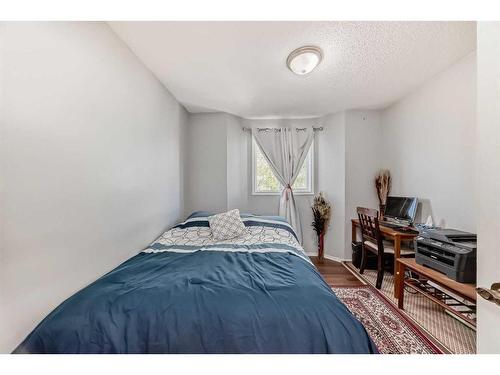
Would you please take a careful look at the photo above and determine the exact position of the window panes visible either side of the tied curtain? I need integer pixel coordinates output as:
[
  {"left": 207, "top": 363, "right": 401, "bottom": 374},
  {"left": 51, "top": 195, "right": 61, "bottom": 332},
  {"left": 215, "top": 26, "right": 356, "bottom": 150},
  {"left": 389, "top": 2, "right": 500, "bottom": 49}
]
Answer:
[{"left": 252, "top": 139, "right": 314, "bottom": 195}]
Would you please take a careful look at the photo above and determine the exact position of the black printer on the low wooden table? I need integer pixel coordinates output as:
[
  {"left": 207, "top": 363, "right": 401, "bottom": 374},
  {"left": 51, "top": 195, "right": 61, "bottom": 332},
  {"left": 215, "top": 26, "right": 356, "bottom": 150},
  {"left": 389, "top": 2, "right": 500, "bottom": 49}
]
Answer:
[{"left": 415, "top": 228, "right": 477, "bottom": 283}]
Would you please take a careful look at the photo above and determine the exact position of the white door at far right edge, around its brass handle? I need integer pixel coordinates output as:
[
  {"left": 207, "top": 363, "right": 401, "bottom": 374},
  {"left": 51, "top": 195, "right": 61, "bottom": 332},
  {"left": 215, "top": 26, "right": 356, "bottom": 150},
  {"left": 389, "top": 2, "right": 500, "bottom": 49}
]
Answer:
[{"left": 477, "top": 22, "right": 500, "bottom": 354}]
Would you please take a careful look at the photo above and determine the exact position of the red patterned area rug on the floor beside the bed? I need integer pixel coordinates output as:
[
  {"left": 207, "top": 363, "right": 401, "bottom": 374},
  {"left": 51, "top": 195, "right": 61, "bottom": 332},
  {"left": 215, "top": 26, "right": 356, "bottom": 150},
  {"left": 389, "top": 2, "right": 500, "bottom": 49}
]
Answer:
[{"left": 332, "top": 285, "right": 443, "bottom": 354}]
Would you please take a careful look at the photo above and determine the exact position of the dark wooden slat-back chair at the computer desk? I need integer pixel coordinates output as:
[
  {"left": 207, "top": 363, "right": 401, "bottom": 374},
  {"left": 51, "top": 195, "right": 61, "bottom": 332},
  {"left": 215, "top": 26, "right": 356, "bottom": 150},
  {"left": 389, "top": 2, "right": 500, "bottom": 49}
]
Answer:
[{"left": 357, "top": 207, "right": 414, "bottom": 289}]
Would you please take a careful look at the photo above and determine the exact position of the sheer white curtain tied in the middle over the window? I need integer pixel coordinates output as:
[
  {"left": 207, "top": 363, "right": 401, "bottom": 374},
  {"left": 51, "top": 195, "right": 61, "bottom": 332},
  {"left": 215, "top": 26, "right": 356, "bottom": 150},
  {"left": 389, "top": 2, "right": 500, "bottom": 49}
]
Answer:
[{"left": 252, "top": 127, "right": 314, "bottom": 243}]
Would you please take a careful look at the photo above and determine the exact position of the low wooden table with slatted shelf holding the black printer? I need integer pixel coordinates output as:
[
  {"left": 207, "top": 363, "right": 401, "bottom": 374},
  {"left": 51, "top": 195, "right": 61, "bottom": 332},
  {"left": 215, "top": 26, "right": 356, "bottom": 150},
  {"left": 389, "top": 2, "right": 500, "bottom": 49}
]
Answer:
[{"left": 395, "top": 258, "right": 477, "bottom": 326}]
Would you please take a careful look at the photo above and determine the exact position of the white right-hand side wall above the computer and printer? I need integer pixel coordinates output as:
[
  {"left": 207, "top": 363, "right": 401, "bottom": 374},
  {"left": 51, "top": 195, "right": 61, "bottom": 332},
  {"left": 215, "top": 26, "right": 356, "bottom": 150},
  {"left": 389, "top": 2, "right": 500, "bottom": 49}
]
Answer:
[{"left": 381, "top": 53, "right": 477, "bottom": 232}]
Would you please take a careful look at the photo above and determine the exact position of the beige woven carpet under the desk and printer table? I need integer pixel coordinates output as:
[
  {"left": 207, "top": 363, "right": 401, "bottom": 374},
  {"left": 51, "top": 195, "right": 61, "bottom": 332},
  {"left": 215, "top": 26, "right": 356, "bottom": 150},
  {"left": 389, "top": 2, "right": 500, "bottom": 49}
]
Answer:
[{"left": 345, "top": 262, "right": 476, "bottom": 354}]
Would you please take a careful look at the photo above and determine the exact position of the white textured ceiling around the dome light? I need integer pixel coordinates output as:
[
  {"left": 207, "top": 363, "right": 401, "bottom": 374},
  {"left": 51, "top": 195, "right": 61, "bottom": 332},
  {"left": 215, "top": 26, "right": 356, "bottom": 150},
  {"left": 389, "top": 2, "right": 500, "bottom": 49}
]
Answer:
[{"left": 109, "top": 22, "right": 476, "bottom": 118}]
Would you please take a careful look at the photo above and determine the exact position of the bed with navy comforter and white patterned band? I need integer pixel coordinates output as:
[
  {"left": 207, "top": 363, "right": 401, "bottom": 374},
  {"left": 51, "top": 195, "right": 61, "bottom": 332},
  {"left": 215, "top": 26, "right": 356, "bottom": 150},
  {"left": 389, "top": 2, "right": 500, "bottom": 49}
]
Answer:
[{"left": 14, "top": 212, "right": 377, "bottom": 353}]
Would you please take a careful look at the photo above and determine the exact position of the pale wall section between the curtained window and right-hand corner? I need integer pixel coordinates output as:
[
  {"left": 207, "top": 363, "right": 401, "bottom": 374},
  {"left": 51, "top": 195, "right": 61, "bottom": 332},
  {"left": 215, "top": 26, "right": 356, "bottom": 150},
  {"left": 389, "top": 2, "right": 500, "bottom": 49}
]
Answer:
[{"left": 317, "top": 110, "right": 381, "bottom": 260}]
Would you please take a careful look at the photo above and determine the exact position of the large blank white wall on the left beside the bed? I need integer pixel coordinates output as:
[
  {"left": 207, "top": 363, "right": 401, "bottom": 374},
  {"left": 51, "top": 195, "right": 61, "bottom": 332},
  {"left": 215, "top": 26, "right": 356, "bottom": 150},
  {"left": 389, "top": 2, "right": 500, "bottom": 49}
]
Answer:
[{"left": 0, "top": 22, "right": 187, "bottom": 352}]
